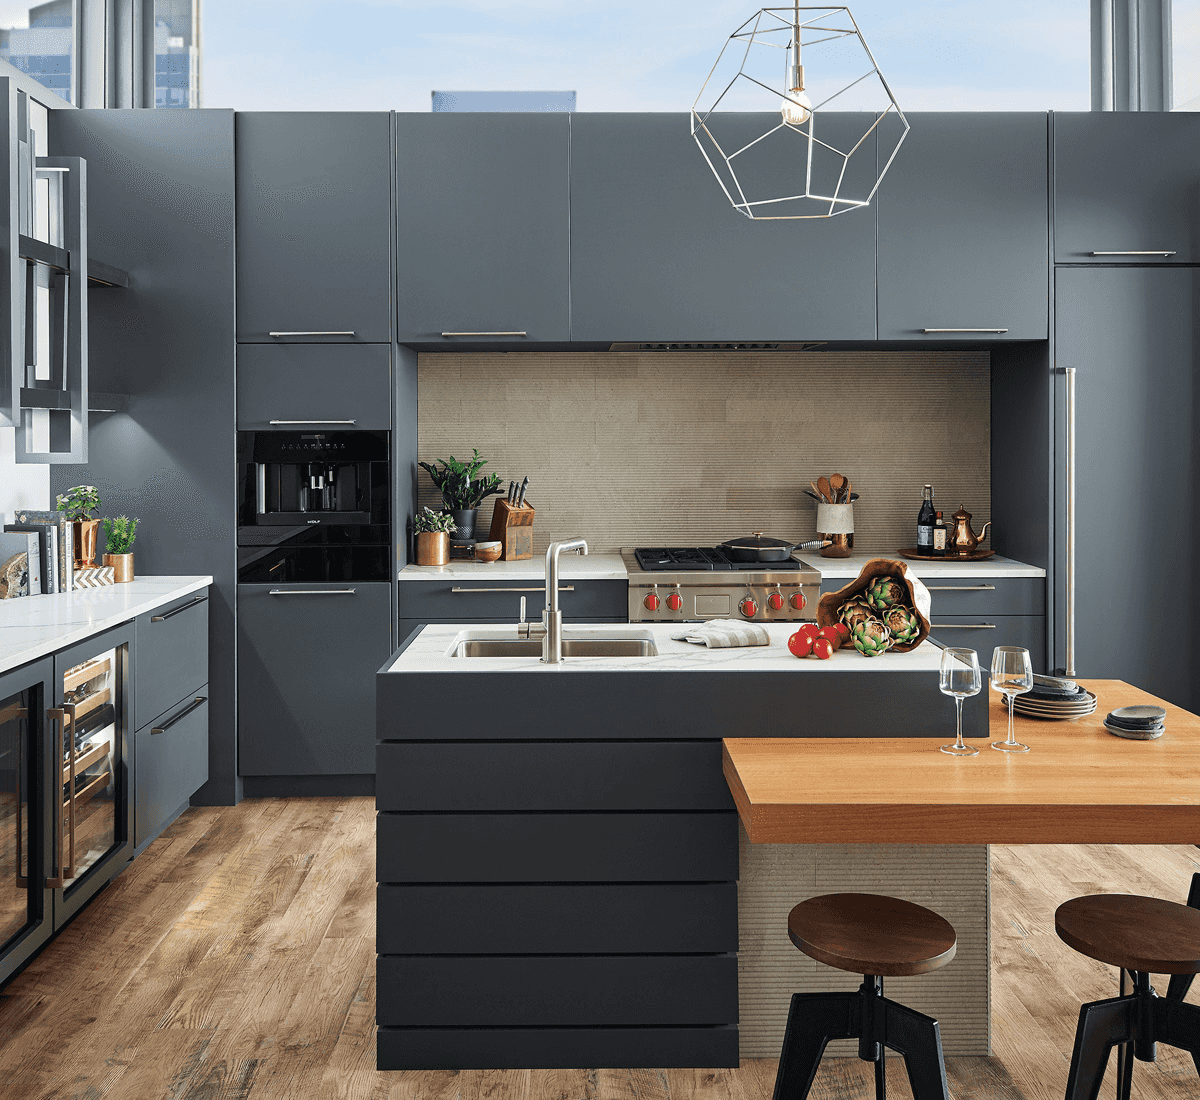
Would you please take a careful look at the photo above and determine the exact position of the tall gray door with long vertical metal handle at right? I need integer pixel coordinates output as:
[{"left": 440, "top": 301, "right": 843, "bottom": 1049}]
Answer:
[{"left": 1055, "top": 266, "right": 1200, "bottom": 710}]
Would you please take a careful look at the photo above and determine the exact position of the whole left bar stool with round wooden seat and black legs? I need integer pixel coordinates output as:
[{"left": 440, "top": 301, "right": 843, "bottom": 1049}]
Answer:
[{"left": 775, "top": 894, "right": 956, "bottom": 1100}]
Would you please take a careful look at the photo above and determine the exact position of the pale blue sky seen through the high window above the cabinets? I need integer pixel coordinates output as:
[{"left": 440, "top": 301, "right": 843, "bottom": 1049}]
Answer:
[{"left": 203, "top": 0, "right": 1099, "bottom": 110}]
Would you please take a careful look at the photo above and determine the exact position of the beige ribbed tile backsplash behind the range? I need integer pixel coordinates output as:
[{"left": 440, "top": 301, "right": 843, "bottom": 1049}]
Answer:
[{"left": 418, "top": 349, "right": 991, "bottom": 553}]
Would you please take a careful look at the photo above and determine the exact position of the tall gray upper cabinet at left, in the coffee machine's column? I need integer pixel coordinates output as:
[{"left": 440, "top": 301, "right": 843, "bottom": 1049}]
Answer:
[{"left": 234, "top": 112, "right": 391, "bottom": 343}]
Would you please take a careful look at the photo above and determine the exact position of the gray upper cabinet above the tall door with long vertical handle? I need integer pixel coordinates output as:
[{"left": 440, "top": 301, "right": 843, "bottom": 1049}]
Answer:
[{"left": 1054, "top": 112, "right": 1200, "bottom": 264}]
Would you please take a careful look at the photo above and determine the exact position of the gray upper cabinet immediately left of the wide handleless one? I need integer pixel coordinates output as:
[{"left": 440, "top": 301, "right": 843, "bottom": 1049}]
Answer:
[{"left": 396, "top": 114, "right": 571, "bottom": 347}]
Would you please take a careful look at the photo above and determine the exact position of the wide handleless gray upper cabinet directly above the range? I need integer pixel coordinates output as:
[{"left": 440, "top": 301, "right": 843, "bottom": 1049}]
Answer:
[{"left": 571, "top": 114, "right": 875, "bottom": 342}]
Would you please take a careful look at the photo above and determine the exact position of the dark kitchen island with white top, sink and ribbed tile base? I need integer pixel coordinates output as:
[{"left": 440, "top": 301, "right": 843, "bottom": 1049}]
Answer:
[{"left": 377, "top": 624, "right": 988, "bottom": 1069}]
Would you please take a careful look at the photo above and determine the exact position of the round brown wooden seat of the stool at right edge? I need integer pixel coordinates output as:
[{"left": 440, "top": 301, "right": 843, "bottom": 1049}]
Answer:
[{"left": 1054, "top": 894, "right": 1200, "bottom": 974}]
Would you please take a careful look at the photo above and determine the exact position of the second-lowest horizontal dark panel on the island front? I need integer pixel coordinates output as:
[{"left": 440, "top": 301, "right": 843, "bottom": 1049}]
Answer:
[{"left": 377, "top": 955, "right": 738, "bottom": 1027}]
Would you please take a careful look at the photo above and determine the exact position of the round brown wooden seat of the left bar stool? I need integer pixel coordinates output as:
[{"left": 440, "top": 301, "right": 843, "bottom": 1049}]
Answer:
[{"left": 787, "top": 894, "right": 955, "bottom": 978}]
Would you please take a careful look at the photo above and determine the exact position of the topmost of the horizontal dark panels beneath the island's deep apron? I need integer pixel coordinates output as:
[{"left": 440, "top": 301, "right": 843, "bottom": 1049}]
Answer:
[{"left": 376, "top": 740, "right": 733, "bottom": 812}]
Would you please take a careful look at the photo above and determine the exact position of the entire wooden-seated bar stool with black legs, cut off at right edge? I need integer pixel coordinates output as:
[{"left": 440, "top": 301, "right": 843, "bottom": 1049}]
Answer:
[{"left": 1054, "top": 879, "right": 1200, "bottom": 1100}]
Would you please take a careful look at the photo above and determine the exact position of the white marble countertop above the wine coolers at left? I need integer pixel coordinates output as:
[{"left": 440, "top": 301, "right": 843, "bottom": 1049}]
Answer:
[{"left": 0, "top": 577, "right": 212, "bottom": 672}]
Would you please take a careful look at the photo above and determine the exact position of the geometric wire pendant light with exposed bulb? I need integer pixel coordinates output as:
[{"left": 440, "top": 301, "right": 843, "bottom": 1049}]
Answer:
[{"left": 691, "top": 4, "right": 908, "bottom": 220}]
